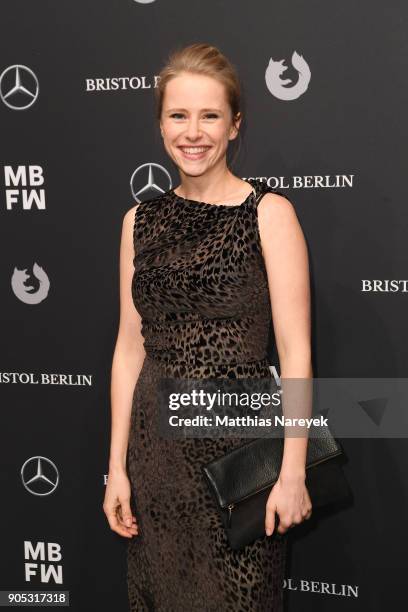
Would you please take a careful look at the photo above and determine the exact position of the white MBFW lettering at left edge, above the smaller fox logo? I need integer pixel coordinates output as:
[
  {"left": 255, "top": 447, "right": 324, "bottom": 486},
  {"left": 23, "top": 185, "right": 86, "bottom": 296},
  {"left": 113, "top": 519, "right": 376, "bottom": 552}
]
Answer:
[{"left": 4, "top": 166, "right": 45, "bottom": 210}]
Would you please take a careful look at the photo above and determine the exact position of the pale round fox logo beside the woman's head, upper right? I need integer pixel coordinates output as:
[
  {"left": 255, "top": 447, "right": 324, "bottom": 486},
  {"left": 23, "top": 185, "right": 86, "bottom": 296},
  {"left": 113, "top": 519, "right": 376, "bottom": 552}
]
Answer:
[{"left": 265, "top": 51, "right": 311, "bottom": 100}]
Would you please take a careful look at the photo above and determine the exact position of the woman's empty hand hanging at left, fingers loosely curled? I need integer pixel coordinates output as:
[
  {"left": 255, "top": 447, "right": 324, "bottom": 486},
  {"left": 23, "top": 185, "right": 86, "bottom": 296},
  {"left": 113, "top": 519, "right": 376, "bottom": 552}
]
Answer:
[{"left": 103, "top": 470, "right": 138, "bottom": 538}]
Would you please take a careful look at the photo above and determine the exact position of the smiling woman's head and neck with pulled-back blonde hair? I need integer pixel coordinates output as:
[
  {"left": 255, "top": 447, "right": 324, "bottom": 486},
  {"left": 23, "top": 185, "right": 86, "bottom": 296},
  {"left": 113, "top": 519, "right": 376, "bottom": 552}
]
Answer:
[{"left": 156, "top": 45, "right": 243, "bottom": 202}]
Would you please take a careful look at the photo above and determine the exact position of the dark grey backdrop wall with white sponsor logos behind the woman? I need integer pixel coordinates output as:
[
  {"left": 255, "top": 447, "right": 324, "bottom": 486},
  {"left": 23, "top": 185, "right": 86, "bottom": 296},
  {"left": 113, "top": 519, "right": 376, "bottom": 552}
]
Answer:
[{"left": 0, "top": 0, "right": 408, "bottom": 612}]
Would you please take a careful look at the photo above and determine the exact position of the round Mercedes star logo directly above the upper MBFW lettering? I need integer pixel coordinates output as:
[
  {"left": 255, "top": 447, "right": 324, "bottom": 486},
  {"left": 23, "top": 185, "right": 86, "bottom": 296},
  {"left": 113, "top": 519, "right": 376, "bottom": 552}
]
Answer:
[{"left": 0, "top": 64, "right": 40, "bottom": 110}]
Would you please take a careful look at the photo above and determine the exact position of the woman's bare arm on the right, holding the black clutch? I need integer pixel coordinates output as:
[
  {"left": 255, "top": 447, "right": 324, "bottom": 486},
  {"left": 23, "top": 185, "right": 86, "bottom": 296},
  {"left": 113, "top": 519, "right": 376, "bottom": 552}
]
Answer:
[{"left": 258, "top": 193, "right": 313, "bottom": 533}]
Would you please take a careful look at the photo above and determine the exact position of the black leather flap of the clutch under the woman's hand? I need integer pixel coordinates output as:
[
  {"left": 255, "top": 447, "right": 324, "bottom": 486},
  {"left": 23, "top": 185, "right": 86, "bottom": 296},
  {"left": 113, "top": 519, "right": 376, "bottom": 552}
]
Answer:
[{"left": 202, "top": 430, "right": 342, "bottom": 508}]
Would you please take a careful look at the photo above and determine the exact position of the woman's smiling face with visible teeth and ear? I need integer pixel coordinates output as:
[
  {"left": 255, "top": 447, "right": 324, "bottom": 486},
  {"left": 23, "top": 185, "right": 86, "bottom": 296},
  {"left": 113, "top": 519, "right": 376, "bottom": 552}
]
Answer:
[{"left": 160, "top": 72, "right": 241, "bottom": 176}]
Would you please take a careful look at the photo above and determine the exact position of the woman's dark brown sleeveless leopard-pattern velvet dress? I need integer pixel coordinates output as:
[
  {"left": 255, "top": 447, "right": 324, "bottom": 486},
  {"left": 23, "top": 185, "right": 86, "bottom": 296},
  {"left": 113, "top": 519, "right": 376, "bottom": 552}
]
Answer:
[{"left": 127, "top": 179, "right": 287, "bottom": 612}]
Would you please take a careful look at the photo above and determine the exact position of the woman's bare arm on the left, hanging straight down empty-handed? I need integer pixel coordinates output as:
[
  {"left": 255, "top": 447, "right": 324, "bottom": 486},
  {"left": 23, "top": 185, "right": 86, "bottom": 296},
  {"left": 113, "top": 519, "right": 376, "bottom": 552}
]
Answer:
[{"left": 103, "top": 204, "right": 146, "bottom": 538}]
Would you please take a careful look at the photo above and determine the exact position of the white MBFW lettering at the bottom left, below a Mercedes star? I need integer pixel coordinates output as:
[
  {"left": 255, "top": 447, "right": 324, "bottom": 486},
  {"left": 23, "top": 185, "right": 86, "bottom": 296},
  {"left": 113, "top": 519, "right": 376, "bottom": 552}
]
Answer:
[{"left": 24, "top": 540, "right": 63, "bottom": 584}]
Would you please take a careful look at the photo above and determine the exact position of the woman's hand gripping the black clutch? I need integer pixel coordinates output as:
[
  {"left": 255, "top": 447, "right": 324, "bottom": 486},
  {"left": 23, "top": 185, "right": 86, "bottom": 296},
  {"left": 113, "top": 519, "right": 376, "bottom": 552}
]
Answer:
[{"left": 265, "top": 473, "right": 312, "bottom": 535}]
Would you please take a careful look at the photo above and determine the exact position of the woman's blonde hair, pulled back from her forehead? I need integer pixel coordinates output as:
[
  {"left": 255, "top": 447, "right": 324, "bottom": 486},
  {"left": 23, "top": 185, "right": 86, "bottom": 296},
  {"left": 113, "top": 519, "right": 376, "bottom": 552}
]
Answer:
[{"left": 154, "top": 43, "right": 242, "bottom": 165}]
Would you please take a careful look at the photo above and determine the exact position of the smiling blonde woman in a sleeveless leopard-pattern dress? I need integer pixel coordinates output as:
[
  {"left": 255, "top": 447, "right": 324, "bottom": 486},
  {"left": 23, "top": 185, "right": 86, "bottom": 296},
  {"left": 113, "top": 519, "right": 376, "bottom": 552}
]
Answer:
[{"left": 104, "top": 44, "right": 312, "bottom": 612}]
